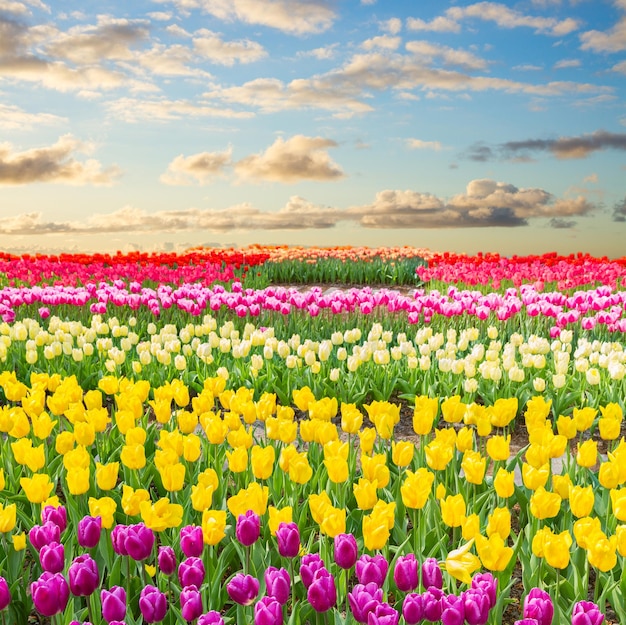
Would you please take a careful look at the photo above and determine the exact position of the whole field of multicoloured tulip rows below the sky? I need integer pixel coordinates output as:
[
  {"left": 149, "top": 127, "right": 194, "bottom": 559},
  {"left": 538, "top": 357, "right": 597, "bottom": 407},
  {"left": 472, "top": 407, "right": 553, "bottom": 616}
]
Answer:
[{"left": 0, "top": 246, "right": 626, "bottom": 625}]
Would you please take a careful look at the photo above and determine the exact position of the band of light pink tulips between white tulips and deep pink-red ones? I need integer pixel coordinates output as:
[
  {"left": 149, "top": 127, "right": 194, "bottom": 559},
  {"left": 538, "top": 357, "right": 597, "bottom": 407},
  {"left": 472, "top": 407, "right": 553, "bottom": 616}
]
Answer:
[{"left": 0, "top": 280, "right": 626, "bottom": 332}]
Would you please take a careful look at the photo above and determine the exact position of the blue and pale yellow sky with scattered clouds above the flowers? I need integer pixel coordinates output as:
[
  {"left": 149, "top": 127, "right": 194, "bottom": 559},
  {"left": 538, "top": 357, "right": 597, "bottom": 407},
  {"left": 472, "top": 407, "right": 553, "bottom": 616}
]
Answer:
[{"left": 0, "top": 0, "right": 626, "bottom": 258}]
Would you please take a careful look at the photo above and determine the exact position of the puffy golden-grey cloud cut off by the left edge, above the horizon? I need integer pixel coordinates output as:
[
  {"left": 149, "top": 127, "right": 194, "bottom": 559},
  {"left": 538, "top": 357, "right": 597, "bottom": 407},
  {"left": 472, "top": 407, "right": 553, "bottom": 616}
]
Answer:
[{"left": 0, "top": 135, "right": 121, "bottom": 185}]
